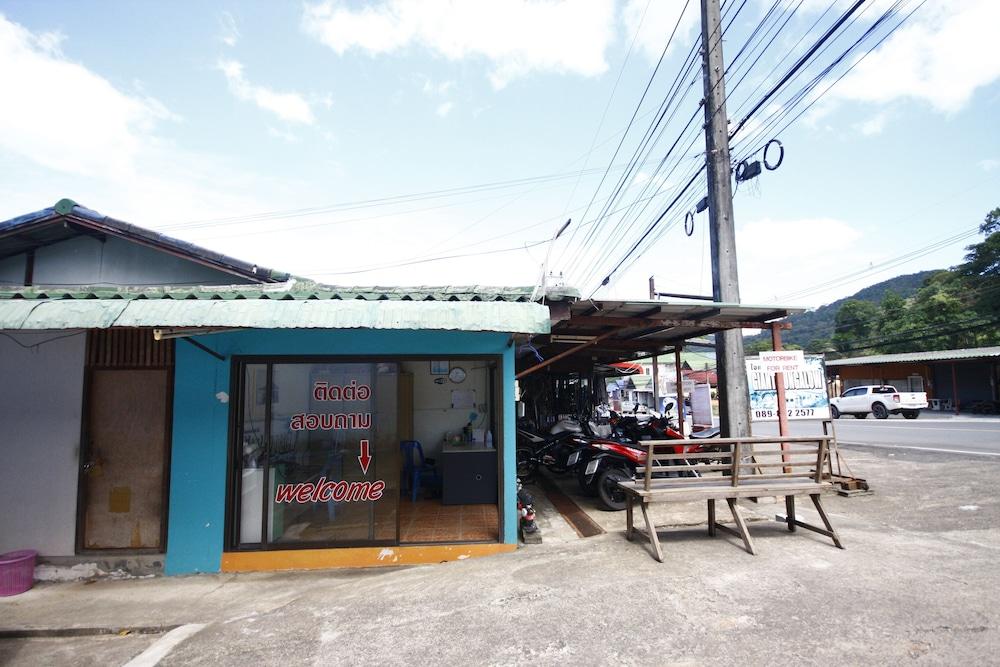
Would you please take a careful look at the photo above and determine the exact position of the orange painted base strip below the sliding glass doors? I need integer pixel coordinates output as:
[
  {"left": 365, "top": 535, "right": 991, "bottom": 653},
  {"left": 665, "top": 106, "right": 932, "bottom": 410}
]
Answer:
[{"left": 222, "top": 544, "right": 517, "bottom": 572}]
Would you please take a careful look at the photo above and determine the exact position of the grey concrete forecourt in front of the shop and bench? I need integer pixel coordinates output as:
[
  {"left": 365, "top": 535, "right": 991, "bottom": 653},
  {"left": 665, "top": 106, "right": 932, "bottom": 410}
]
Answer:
[{"left": 0, "top": 448, "right": 1000, "bottom": 665}]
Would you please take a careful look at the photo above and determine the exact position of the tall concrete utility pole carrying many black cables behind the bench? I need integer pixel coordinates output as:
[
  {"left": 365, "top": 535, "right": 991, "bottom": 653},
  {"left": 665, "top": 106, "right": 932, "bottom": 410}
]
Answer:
[{"left": 701, "top": 0, "right": 750, "bottom": 438}]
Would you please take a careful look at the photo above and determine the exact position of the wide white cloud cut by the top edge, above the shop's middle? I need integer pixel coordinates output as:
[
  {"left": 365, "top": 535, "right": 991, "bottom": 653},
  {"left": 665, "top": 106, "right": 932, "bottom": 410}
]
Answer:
[{"left": 303, "top": 0, "right": 615, "bottom": 88}]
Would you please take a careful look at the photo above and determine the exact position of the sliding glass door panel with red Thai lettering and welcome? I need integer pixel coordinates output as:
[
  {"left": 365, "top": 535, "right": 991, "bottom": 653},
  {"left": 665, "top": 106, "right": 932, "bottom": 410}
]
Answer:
[{"left": 231, "top": 358, "right": 400, "bottom": 549}]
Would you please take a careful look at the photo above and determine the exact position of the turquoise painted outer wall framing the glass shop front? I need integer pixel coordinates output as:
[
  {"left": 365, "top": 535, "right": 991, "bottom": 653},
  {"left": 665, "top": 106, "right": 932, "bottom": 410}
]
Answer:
[{"left": 165, "top": 329, "right": 517, "bottom": 574}]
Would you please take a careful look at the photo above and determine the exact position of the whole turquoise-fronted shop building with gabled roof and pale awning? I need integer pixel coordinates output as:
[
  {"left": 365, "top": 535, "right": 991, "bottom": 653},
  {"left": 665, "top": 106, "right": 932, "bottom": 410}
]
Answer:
[{"left": 0, "top": 202, "right": 549, "bottom": 574}]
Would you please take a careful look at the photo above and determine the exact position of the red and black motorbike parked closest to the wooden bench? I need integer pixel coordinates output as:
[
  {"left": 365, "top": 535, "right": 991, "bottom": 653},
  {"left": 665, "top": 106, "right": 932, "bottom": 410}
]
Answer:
[{"left": 577, "top": 408, "right": 719, "bottom": 511}]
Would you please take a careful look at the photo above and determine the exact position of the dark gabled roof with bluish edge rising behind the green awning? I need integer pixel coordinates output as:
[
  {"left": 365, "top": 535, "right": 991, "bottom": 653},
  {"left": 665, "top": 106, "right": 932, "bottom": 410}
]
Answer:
[{"left": 0, "top": 199, "right": 289, "bottom": 283}]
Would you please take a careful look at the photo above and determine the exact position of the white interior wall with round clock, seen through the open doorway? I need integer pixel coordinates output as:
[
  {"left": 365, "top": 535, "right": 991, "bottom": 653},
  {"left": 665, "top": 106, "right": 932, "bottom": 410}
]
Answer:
[{"left": 401, "top": 359, "right": 497, "bottom": 457}]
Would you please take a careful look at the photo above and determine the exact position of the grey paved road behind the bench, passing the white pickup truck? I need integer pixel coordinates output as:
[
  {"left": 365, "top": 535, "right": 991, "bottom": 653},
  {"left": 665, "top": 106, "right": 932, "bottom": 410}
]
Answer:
[{"left": 754, "top": 413, "right": 1000, "bottom": 456}]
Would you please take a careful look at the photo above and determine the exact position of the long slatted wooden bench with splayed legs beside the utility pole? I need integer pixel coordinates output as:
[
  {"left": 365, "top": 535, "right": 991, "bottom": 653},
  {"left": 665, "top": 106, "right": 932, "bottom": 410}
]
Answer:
[{"left": 618, "top": 435, "right": 844, "bottom": 563}]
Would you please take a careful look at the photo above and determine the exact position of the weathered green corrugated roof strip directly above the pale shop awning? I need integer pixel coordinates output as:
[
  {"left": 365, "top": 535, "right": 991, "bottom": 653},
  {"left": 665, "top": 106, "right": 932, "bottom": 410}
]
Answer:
[{"left": 0, "top": 280, "right": 579, "bottom": 302}]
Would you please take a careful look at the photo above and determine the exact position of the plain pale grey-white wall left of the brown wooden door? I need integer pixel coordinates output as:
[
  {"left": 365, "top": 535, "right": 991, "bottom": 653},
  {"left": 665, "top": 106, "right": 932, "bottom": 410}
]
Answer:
[{"left": 0, "top": 331, "right": 87, "bottom": 556}]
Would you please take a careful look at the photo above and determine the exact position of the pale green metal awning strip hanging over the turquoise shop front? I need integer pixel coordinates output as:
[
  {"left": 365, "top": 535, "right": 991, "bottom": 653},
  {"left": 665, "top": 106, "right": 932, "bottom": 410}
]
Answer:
[{"left": 0, "top": 299, "right": 549, "bottom": 334}]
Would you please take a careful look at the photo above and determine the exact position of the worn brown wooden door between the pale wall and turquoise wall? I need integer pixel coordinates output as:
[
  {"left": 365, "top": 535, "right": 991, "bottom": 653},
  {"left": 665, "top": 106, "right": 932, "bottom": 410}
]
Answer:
[{"left": 79, "top": 369, "right": 170, "bottom": 550}]
